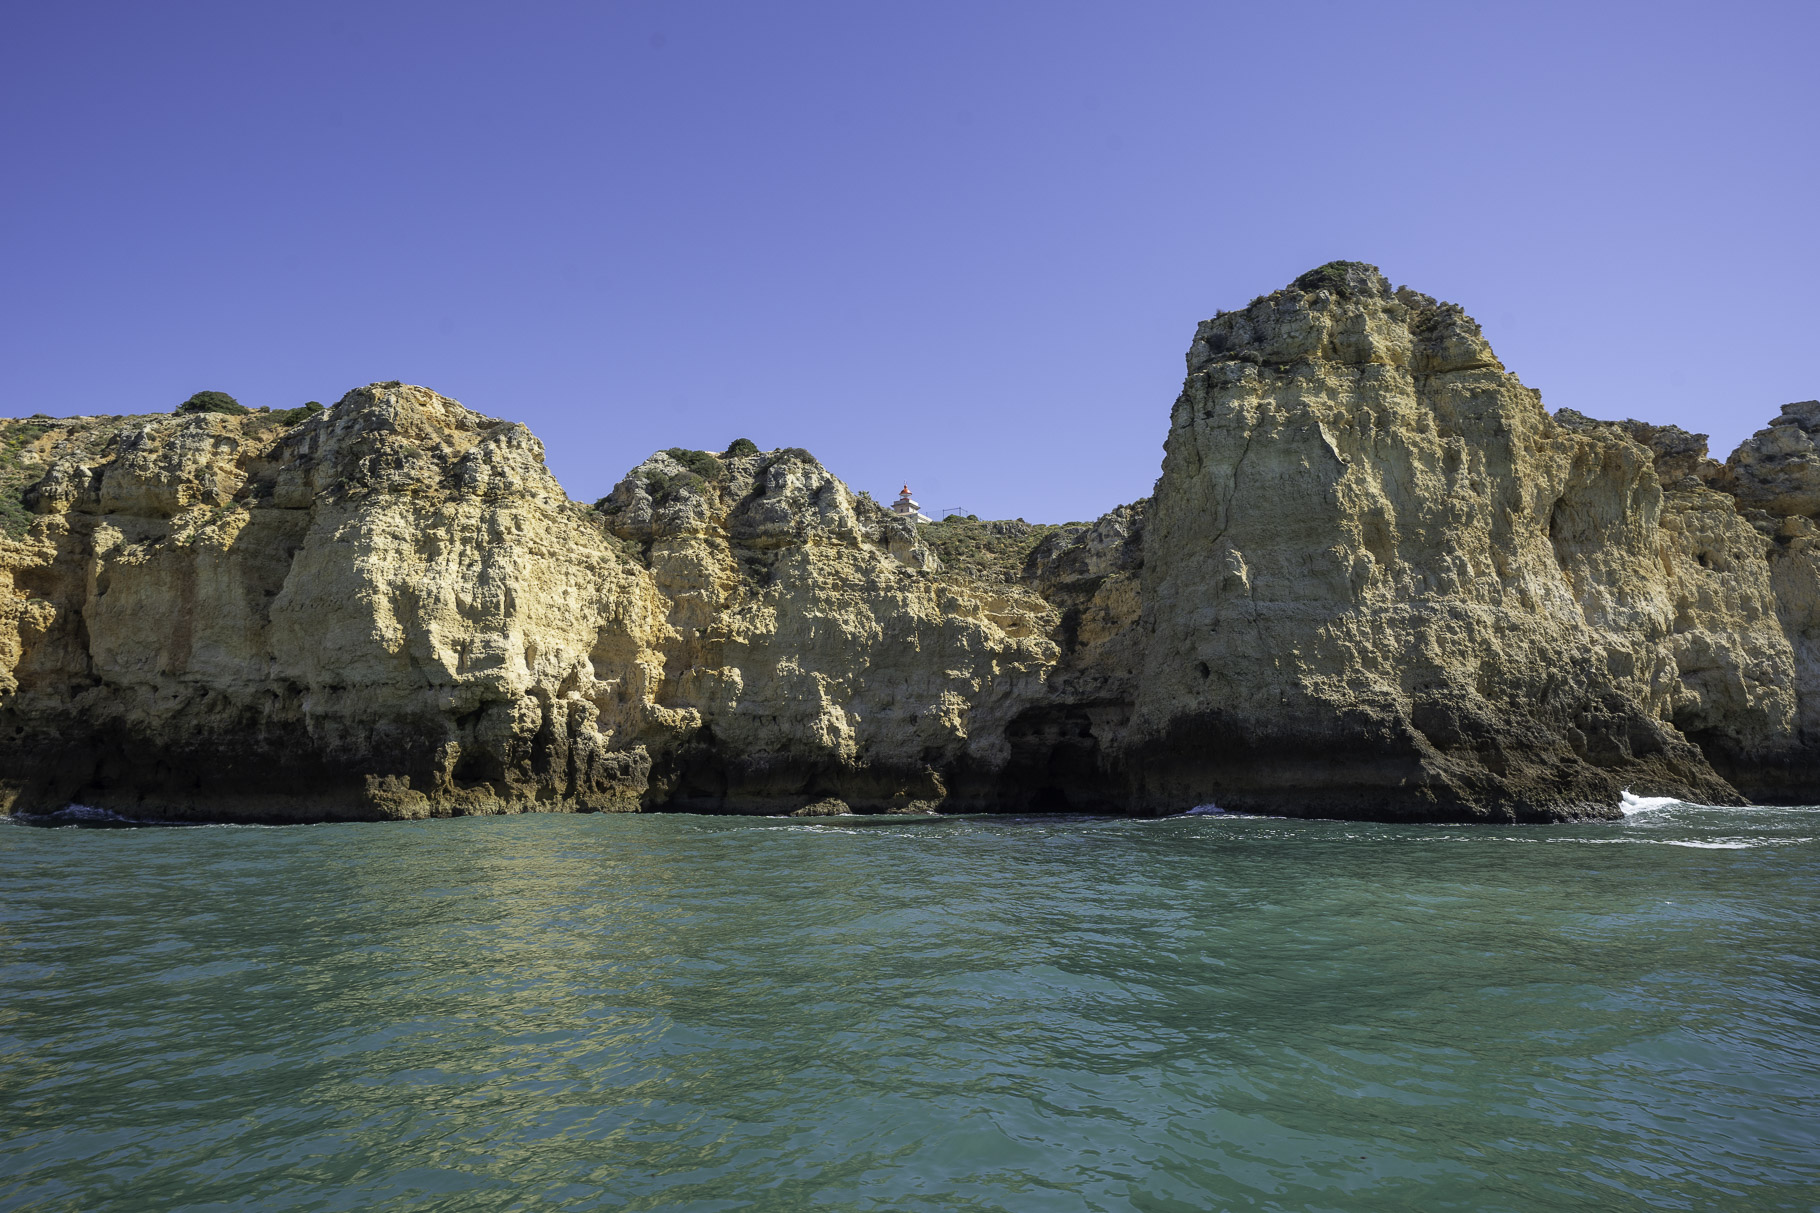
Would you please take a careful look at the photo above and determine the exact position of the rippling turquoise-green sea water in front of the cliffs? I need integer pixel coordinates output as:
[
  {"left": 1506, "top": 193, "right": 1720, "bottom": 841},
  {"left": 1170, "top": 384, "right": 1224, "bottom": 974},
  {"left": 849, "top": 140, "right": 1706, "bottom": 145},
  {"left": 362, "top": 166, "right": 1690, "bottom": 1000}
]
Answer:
[{"left": 0, "top": 805, "right": 1820, "bottom": 1213}]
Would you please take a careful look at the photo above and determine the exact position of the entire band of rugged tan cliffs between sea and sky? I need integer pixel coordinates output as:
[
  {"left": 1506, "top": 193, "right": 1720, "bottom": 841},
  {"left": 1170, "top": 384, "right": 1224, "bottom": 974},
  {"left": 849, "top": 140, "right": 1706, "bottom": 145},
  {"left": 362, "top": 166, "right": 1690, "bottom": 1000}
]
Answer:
[{"left": 0, "top": 262, "right": 1820, "bottom": 820}]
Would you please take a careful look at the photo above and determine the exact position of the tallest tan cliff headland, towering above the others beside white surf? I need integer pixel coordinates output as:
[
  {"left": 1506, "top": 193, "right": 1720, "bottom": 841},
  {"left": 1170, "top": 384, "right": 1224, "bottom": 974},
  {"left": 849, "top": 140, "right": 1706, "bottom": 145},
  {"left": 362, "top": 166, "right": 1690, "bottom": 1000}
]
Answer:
[{"left": 1117, "top": 264, "right": 1796, "bottom": 818}]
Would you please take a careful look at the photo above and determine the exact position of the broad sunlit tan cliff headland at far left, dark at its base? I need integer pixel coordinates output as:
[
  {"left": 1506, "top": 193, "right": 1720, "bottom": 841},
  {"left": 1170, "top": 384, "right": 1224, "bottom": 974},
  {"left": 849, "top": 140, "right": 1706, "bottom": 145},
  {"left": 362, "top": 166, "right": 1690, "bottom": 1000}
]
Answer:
[{"left": 0, "top": 384, "right": 662, "bottom": 820}]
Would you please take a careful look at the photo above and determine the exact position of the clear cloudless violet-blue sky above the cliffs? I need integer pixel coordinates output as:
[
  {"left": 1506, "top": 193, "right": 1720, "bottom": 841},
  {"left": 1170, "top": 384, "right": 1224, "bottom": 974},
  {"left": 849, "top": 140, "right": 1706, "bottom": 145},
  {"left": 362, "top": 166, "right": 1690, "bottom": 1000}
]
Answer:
[{"left": 0, "top": 0, "right": 1820, "bottom": 521}]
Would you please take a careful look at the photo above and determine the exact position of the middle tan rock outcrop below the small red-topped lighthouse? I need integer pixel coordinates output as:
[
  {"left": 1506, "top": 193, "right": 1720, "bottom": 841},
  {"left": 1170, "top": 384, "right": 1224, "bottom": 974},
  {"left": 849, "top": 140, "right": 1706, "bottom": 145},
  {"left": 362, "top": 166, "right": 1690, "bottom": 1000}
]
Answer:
[{"left": 601, "top": 437, "right": 1056, "bottom": 812}]
